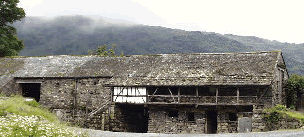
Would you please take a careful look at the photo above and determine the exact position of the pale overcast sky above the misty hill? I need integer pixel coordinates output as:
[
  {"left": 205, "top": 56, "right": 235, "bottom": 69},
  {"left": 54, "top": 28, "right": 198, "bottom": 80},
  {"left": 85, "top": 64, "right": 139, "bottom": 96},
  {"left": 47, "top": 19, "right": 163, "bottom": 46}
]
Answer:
[{"left": 20, "top": 0, "right": 304, "bottom": 43}]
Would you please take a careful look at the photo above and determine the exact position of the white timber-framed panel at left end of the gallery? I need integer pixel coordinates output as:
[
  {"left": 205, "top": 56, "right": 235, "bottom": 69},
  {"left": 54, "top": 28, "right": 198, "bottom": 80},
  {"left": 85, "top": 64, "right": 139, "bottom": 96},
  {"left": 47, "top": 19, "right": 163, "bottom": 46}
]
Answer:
[{"left": 113, "top": 87, "right": 147, "bottom": 103}]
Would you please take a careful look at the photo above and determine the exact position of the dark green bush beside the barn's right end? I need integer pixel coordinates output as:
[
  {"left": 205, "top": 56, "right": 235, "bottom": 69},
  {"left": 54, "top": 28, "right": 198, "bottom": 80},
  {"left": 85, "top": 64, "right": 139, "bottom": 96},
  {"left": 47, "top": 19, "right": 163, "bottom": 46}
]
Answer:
[{"left": 286, "top": 74, "right": 304, "bottom": 107}]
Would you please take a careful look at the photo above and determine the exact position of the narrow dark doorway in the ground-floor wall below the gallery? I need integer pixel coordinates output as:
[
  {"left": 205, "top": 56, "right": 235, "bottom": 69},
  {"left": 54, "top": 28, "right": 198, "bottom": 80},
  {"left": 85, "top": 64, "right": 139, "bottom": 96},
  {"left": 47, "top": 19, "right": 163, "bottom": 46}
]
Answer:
[{"left": 206, "top": 111, "right": 217, "bottom": 134}]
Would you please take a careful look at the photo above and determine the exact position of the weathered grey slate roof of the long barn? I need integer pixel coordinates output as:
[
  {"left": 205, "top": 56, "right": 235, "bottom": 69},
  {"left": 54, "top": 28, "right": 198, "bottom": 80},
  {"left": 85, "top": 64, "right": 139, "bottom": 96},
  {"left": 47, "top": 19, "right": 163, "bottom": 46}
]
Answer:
[{"left": 0, "top": 51, "right": 281, "bottom": 86}]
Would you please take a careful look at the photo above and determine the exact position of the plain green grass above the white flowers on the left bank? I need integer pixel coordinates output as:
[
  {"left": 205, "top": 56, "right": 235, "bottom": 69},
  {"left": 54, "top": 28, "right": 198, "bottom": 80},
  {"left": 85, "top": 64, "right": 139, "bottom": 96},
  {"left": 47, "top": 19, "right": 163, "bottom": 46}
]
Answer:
[{"left": 0, "top": 96, "right": 60, "bottom": 123}]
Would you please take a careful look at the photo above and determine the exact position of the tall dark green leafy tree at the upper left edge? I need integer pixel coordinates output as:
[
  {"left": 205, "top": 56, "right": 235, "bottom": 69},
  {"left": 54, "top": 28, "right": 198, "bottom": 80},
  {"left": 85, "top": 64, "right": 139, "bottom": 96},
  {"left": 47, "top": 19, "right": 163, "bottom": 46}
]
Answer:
[{"left": 0, "top": 0, "right": 25, "bottom": 57}]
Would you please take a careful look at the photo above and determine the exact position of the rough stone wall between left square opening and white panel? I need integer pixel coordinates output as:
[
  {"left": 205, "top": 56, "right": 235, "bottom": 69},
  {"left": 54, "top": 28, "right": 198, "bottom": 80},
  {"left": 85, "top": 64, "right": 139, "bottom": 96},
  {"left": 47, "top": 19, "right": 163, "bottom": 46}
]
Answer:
[{"left": 15, "top": 78, "right": 111, "bottom": 129}]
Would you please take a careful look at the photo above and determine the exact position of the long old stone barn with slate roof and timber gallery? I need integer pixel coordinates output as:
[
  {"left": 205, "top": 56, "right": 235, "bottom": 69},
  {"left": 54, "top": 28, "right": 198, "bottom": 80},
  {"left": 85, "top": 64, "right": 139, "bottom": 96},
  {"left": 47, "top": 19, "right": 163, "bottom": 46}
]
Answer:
[{"left": 0, "top": 51, "right": 288, "bottom": 133}]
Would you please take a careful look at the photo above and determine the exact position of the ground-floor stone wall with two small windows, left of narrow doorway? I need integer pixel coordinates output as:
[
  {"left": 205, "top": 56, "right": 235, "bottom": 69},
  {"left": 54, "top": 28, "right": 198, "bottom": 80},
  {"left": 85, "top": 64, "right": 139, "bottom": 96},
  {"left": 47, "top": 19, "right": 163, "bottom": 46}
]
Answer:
[{"left": 148, "top": 106, "right": 206, "bottom": 133}]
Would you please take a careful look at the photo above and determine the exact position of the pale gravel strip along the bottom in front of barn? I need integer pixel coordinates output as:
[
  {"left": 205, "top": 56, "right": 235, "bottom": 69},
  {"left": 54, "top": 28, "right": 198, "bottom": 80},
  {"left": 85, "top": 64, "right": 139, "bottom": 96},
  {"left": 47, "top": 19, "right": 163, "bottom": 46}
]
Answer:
[{"left": 89, "top": 130, "right": 304, "bottom": 137}]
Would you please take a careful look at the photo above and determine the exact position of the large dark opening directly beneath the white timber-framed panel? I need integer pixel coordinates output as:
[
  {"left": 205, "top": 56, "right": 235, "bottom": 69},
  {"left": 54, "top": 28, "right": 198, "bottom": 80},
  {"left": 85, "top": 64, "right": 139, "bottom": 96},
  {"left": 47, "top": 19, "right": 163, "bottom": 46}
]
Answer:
[{"left": 119, "top": 104, "right": 149, "bottom": 133}]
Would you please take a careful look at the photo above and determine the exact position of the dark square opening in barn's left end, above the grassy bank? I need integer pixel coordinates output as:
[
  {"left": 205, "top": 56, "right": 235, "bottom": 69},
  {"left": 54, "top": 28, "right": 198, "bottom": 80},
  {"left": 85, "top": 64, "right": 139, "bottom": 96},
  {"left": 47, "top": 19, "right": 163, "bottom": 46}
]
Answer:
[{"left": 21, "top": 83, "right": 41, "bottom": 102}]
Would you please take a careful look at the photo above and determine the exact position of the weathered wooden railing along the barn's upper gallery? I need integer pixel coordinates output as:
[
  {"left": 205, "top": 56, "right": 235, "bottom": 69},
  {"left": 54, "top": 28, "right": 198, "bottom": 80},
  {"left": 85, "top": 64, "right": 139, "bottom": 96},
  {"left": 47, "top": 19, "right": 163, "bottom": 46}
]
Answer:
[{"left": 112, "top": 88, "right": 272, "bottom": 105}]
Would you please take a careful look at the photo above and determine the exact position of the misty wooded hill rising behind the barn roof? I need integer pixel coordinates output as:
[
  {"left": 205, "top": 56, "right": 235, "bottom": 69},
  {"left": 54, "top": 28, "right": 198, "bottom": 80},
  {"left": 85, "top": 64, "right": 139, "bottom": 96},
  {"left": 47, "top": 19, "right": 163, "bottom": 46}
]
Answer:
[{"left": 14, "top": 16, "right": 304, "bottom": 74}]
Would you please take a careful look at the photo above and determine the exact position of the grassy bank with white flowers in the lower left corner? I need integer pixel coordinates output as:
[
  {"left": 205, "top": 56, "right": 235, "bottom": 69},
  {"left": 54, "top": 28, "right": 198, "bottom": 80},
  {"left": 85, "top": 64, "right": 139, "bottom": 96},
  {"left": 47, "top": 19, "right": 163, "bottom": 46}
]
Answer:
[{"left": 0, "top": 95, "right": 88, "bottom": 137}]
